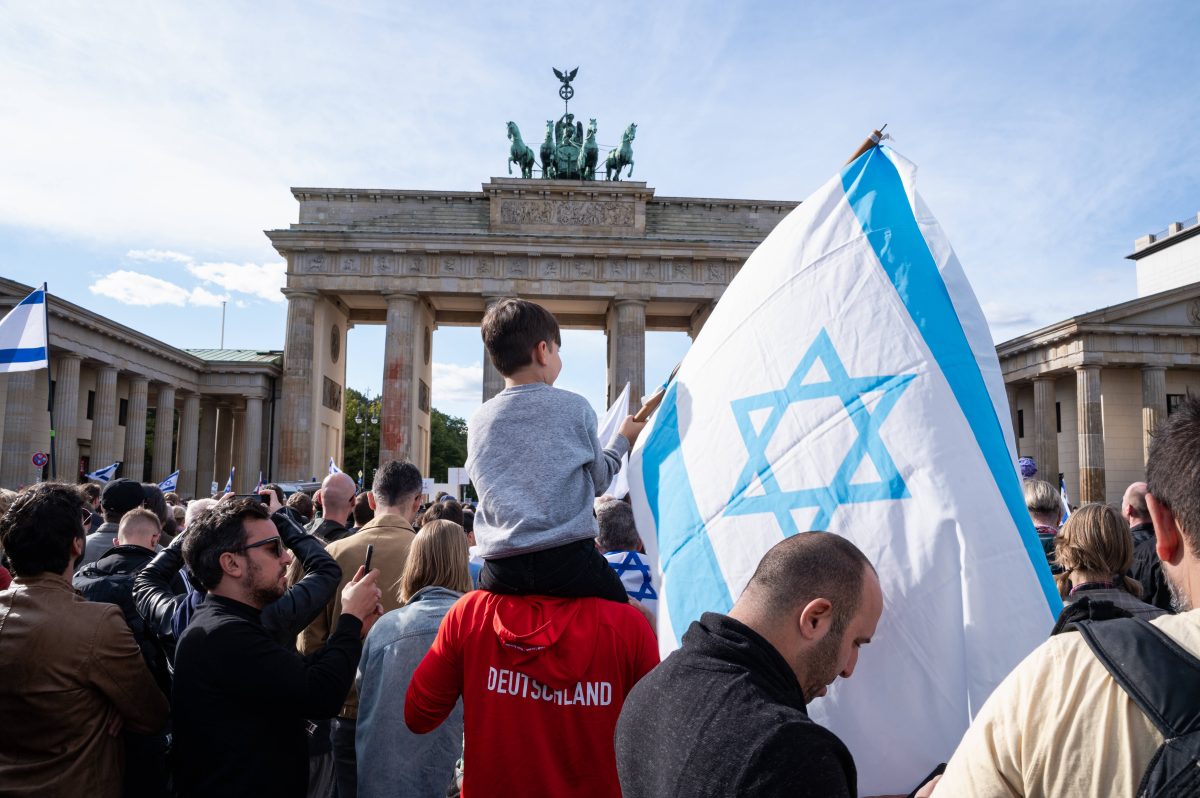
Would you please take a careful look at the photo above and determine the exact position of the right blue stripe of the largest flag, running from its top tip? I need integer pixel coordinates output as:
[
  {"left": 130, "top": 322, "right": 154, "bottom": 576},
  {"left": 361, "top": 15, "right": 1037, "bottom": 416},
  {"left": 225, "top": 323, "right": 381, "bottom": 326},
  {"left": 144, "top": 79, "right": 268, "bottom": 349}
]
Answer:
[{"left": 841, "top": 148, "right": 1062, "bottom": 614}]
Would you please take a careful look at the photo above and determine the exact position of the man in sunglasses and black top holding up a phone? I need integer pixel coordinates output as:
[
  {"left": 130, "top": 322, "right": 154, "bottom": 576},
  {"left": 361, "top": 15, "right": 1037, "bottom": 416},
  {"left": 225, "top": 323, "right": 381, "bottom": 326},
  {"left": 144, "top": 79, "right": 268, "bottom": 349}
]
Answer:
[{"left": 173, "top": 499, "right": 380, "bottom": 798}]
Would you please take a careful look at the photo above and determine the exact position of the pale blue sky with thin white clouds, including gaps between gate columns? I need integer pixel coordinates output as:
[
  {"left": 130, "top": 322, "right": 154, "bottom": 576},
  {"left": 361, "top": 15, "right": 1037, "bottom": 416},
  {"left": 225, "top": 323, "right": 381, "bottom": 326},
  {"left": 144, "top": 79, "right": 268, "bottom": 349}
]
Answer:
[{"left": 0, "top": 1, "right": 1200, "bottom": 415}]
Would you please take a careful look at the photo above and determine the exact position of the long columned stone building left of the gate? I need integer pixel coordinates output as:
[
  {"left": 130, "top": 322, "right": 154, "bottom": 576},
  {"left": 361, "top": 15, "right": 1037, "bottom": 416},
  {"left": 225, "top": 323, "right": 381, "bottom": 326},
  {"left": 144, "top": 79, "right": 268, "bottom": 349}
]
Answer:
[{"left": 0, "top": 278, "right": 283, "bottom": 498}]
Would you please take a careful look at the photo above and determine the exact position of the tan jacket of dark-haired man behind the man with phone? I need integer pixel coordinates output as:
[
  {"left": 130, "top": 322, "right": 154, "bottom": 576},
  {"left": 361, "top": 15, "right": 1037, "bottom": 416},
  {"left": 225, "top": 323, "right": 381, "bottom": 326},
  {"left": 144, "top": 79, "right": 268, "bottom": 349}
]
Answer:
[{"left": 299, "top": 515, "right": 416, "bottom": 719}]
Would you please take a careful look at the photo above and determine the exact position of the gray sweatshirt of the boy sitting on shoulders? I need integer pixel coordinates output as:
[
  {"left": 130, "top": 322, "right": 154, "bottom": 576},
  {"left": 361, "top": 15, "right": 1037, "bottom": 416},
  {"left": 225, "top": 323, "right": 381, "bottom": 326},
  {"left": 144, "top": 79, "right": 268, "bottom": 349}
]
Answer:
[{"left": 467, "top": 383, "right": 629, "bottom": 559}]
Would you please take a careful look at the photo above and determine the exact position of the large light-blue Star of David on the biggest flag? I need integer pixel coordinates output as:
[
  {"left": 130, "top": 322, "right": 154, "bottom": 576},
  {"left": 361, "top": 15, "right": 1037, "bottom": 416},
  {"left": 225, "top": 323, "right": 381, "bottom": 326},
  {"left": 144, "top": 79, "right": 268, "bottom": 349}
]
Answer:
[{"left": 725, "top": 329, "right": 913, "bottom": 535}]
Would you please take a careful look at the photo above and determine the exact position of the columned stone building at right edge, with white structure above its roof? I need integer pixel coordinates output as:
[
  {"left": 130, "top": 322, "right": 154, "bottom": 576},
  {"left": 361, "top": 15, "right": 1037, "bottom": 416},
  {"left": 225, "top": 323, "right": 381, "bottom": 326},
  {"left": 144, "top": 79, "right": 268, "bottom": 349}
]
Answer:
[{"left": 997, "top": 220, "right": 1200, "bottom": 504}]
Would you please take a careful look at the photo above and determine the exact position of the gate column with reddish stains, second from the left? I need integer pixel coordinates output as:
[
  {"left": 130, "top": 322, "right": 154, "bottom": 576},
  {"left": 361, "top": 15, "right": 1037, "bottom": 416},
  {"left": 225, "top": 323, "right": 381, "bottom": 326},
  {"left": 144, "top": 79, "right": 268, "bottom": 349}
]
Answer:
[{"left": 379, "top": 294, "right": 420, "bottom": 463}]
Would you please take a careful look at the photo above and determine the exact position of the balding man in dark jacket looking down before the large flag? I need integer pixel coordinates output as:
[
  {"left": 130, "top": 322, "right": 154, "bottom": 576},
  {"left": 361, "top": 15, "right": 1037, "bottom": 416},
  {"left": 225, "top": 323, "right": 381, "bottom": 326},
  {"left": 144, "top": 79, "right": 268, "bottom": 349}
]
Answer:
[{"left": 617, "top": 532, "right": 883, "bottom": 798}]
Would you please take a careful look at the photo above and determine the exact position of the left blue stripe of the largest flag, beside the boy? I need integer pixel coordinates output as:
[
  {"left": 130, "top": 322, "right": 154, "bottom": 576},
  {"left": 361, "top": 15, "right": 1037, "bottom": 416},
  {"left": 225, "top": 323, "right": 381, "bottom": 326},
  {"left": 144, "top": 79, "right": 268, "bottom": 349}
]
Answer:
[{"left": 642, "top": 383, "right": 733, "bottom": 643}]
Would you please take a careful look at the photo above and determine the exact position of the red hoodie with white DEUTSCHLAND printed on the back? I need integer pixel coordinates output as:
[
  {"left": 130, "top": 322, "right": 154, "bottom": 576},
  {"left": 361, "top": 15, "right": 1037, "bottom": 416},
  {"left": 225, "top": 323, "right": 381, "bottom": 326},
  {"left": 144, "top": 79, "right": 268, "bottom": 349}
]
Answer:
[{"left": 404, "top": 590, "right": 659, "bottom": 798}]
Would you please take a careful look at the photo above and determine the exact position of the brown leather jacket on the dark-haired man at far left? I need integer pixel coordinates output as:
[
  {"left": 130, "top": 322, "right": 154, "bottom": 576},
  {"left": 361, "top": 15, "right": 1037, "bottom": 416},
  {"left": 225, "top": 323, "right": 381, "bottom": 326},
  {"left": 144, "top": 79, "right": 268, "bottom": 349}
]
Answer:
[{"left": 0, "top": 574, "right": 168, "bottom": 798}]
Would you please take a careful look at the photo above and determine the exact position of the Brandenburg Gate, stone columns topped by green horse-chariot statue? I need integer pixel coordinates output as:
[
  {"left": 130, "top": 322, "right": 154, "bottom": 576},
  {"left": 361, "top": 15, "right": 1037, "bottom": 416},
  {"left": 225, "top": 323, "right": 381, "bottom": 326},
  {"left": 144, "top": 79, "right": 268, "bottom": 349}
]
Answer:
[{"left": 266, "top": 68, "right": 796, "bottom": 480}]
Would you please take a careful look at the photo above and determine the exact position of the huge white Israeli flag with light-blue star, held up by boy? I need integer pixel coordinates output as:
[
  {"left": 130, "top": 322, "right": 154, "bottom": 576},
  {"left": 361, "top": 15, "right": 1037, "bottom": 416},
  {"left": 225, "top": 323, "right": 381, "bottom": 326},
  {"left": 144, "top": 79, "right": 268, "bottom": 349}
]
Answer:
[{"left": 630, "top": 146, "right": 1061, "bottom": 794}]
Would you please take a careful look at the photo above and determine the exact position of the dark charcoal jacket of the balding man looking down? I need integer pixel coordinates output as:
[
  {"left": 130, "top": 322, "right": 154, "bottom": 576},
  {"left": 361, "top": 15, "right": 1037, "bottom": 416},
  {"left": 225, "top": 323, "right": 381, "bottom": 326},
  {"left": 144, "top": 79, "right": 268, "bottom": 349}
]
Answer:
[{"left": 617, "top": 612, "right": 858, "bottom": 798}]
